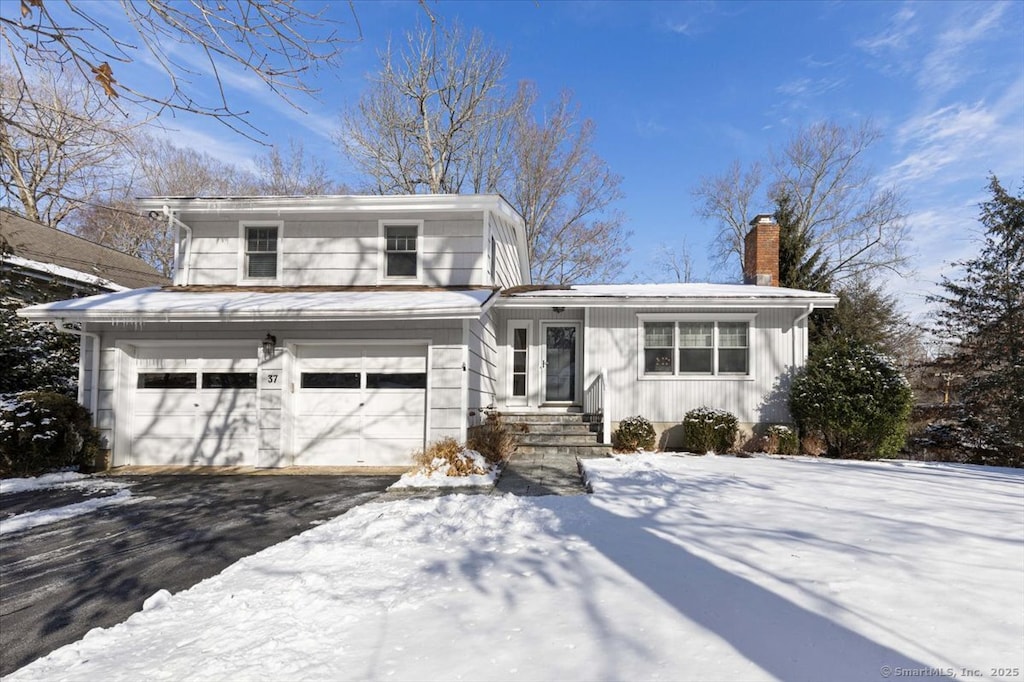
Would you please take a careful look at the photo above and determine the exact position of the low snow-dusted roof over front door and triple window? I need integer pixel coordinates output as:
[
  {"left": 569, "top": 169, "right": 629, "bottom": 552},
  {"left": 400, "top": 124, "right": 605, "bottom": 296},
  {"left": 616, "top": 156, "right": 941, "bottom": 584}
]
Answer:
[{"left": 502, "top": 284, "right": 839, "bottom": 308}]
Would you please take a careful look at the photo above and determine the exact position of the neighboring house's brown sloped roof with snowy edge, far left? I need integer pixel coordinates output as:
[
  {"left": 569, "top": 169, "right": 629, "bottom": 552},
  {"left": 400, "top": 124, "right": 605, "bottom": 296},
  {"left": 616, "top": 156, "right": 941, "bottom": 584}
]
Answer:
[{"left": 0, "top": 210, "right": 168, "bottom": 289}]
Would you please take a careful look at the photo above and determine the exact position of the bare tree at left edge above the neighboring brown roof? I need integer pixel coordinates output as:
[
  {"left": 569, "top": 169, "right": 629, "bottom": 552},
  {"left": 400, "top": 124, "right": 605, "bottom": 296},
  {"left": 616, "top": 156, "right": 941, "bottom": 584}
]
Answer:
[{"left": 0, "top": 67, "right": 130, "bottom": 227}]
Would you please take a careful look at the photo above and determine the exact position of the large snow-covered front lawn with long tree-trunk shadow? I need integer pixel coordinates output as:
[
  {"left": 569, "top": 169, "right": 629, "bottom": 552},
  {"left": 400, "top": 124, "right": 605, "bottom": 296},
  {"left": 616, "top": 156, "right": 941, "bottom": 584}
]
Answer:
[{"left": 8, "top": 455, "right": 1024, "bottom": 681}]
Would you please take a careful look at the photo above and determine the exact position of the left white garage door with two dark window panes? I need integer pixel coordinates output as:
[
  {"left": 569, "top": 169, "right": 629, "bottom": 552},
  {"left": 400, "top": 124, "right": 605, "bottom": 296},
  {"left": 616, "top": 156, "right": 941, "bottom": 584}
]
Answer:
[{"left": 131, "top": 347, "right": 258, "bottom": 466}]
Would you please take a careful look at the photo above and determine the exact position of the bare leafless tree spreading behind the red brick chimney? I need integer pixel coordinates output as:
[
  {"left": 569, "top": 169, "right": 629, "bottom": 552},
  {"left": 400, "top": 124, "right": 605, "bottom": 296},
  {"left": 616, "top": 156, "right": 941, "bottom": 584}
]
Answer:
[{"left": 693, "top": 122, "right": 907, "bottom": 284}]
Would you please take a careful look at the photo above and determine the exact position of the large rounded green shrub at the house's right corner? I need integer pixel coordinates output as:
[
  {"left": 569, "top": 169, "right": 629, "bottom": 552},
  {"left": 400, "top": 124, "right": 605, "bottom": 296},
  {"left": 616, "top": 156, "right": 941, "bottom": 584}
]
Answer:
[{"left": 790, "top": 343, "right": 912, "bottom": 459}]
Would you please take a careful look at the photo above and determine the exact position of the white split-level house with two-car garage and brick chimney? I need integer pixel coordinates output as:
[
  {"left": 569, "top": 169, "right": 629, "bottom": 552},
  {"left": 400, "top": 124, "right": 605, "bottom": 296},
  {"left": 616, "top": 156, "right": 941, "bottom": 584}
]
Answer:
[{"left": 19, "top": 195, "right": 837, "bottom": 467}]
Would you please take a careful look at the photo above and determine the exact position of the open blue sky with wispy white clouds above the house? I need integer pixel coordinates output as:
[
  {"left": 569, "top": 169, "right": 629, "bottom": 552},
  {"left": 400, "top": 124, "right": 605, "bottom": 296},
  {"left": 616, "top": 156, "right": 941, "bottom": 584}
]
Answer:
[{"left": 16, "top": 0, "right": 1024, "bottom": 319}]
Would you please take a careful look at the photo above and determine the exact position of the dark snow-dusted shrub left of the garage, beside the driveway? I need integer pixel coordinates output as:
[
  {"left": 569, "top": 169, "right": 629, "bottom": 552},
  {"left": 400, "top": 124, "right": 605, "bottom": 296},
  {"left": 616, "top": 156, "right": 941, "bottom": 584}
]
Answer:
[{"left": 0, "top": 391, "right": 99, "bottom": 477}]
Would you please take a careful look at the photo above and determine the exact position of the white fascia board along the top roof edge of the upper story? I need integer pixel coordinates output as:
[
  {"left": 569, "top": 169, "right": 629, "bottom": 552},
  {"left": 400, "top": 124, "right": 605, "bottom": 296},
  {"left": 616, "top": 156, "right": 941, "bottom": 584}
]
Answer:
[{"left": 135, "top": 195, "right": 523, "bottom": 219}]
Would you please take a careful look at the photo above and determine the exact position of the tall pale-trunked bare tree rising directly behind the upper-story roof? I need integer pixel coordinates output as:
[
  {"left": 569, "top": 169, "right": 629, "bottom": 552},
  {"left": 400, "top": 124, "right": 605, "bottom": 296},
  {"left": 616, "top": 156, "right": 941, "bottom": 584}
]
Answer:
[{"left": 337, "top": 25, "right": 523, "bottom": 195}]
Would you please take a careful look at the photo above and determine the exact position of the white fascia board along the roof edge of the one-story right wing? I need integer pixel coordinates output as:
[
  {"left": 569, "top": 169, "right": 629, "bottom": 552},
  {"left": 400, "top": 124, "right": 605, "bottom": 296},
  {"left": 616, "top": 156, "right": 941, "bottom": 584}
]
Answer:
[{"left": 498, "top": 296, "right": 839, "bottom": 308}]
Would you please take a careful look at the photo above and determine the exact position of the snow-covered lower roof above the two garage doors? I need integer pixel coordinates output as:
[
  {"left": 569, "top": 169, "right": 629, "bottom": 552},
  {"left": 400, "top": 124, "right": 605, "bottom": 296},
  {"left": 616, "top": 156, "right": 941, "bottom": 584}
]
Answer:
[{"left": 17, "top": 287, "right": 498, "bottom": 324}]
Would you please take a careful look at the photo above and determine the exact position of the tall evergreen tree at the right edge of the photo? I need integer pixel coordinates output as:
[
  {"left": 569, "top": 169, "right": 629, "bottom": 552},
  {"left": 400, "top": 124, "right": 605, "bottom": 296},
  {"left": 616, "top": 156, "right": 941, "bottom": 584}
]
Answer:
[{"left": 932, "top": 175, "right": 1024, "bottom": 448}]
